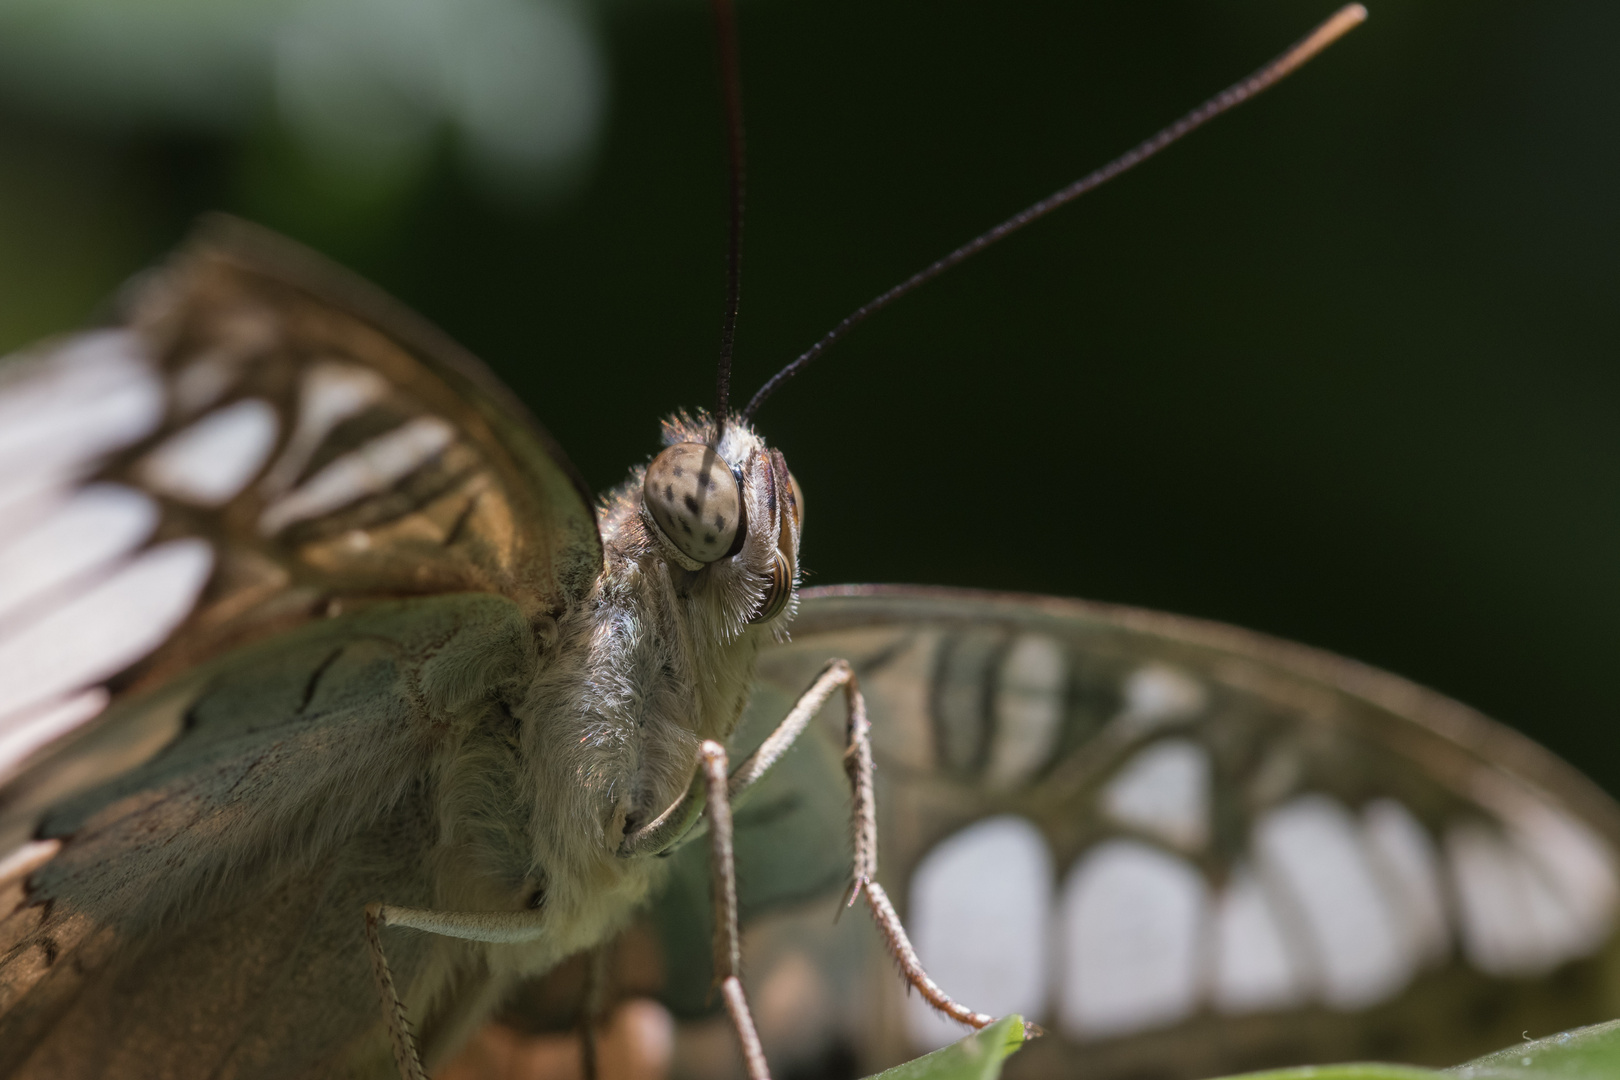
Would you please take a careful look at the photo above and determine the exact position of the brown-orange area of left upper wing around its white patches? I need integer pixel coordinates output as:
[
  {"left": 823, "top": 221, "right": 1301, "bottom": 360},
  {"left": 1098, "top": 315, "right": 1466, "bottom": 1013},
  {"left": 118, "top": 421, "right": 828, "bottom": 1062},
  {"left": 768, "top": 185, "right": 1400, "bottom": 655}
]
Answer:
[{"left": 105, "top": 217, "right": 601, "bottom": 685}]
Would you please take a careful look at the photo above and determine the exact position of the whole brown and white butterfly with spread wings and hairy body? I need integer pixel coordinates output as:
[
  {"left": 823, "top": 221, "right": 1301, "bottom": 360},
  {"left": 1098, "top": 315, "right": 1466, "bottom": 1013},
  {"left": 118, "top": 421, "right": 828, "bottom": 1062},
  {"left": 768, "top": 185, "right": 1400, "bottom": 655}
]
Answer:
[{"left": 0, "top": 6, "right": 1620, "bottom": 1077}]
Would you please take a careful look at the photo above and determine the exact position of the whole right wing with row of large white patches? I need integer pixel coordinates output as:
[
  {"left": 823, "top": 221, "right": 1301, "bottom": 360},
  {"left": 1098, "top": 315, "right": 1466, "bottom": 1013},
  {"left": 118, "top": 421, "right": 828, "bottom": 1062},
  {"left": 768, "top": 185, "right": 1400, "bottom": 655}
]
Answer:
[{"left": 644, "top": 588, "right": 1620, "bottom": 1077}]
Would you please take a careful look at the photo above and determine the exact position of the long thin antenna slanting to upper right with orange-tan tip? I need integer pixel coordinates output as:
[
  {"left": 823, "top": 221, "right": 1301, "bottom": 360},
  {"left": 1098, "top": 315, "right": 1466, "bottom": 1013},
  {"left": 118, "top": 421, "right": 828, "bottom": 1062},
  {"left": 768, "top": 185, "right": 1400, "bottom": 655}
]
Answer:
[{"left": 742, "top": 3, "right": 1367, "bottom": 423}]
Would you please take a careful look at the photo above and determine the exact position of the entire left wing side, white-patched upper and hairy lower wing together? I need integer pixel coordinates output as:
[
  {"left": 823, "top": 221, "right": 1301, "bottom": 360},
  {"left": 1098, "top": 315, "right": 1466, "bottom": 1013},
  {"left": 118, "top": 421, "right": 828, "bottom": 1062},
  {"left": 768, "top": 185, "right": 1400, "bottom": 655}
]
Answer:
[{"left": 0, "top": 220, "right": 601, "bottom": 1075}]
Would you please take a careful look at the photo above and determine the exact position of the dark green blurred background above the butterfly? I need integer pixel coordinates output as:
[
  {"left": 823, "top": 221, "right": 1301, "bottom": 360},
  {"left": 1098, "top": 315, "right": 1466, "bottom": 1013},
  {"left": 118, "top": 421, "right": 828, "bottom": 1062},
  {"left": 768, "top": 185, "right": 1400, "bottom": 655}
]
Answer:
[{"left": 0, "top": 0, "right": 1620, "bottom": 792}]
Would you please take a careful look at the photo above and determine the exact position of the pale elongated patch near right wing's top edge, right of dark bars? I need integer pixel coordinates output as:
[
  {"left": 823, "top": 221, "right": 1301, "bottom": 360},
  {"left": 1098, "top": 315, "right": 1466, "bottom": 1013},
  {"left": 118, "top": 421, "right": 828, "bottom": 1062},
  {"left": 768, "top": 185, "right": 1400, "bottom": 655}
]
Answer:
[{"left": 985, "top": 633, "right": 1069, "bottom": 790}]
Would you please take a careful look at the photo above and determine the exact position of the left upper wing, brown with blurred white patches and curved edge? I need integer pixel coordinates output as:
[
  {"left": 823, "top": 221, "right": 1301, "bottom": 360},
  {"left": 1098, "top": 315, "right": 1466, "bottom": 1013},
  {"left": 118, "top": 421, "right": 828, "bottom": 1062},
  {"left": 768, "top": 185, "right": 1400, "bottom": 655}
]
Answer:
[{"left": 0, "top": 219, "right": 601, "bottom": 858}]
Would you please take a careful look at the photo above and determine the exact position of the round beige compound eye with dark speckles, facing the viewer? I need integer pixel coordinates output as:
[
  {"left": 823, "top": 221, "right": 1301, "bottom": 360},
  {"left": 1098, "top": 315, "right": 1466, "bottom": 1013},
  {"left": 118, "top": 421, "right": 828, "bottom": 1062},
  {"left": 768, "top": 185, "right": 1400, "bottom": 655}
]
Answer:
[{"left": 642, "top": 442, "right": 744, "bottom": 562}]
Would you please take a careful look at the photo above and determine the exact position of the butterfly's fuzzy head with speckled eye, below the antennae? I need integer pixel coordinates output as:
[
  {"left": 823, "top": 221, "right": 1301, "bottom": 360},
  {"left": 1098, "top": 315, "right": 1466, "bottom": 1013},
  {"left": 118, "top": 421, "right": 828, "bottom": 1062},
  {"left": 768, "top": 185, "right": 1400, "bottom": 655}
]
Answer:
[{"left": 625, "top": 416, "right": 804, "bottom": 634}]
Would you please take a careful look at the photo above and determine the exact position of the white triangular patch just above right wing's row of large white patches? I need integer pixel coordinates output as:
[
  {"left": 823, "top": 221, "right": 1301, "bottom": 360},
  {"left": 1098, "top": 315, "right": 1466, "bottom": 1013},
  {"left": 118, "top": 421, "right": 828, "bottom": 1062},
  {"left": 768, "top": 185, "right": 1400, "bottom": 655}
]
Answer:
[{"left": 1102, "top": 738, "right": 1212, "bottom": 852}]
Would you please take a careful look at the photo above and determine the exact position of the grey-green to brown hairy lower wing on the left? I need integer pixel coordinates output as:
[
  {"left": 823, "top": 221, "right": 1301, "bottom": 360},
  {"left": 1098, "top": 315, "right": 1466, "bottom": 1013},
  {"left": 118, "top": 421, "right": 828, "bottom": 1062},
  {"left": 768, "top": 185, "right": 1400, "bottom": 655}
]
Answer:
[{"left": 0, "top": 594, "right": 536, "bottom": 1077}]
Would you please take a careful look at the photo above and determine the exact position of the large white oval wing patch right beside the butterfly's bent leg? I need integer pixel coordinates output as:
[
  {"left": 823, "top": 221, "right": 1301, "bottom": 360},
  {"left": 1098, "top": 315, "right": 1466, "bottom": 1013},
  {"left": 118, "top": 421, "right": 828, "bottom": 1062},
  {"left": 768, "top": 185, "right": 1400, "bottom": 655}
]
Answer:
[{"left": 906, "top": 814, "right": 1053, "bottom": 1049}]
